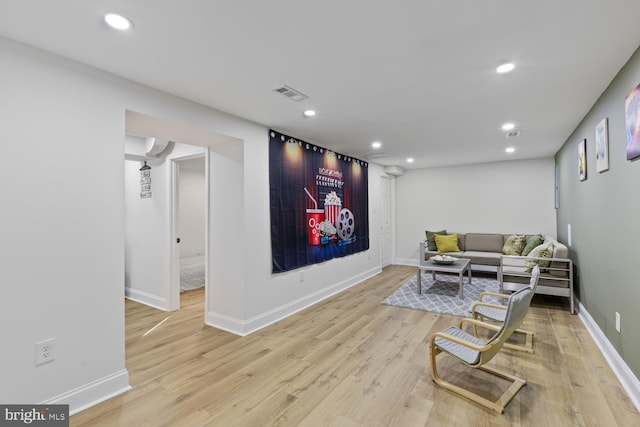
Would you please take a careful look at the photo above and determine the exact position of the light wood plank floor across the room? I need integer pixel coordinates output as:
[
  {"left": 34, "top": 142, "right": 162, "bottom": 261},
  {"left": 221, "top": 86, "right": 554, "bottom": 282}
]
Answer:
[{"left": 71, "top": 266, "right": 640, "bottom": 427}]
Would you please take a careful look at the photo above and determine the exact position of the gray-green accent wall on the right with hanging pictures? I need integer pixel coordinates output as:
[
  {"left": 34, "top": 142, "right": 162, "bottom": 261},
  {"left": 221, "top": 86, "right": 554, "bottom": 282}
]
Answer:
[{"left": 556, "top": 47, "right": 640, "bottom": 377}]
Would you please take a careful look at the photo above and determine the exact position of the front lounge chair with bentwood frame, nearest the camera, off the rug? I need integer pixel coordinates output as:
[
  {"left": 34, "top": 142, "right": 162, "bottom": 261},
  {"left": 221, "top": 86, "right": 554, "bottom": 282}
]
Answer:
[{"left": 429, "top": 287, "right": 533, "bottom": 413}]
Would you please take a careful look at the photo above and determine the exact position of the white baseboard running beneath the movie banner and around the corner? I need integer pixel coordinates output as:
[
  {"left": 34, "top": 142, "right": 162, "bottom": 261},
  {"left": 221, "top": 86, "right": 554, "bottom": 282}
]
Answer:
[{"left": 205, "top": 266, "right": 382, "bottom": 336}]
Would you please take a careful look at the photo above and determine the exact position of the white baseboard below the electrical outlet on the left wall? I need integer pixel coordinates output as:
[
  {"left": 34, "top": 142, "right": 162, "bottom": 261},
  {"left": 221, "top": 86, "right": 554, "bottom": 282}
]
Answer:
[{"left": 42, "top": 369, "right": 131, "bottom": 415}]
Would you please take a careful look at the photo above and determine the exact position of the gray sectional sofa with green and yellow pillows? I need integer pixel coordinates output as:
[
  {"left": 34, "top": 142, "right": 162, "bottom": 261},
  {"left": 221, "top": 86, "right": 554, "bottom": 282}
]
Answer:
[{"left": 419, "top": 233, "right": 575, "bottom": 314}]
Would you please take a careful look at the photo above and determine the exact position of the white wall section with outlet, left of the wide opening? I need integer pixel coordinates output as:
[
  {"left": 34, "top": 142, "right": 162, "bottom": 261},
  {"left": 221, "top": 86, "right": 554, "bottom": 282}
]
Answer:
[{"left": 0, "top": 38, "right": 128, "bottom": 410}]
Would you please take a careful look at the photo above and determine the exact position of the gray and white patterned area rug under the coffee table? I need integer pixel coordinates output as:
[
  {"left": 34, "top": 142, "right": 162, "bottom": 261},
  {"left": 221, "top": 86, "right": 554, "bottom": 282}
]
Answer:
[{"left": 382, "top": 272, "right": 503, "bottom": 317}]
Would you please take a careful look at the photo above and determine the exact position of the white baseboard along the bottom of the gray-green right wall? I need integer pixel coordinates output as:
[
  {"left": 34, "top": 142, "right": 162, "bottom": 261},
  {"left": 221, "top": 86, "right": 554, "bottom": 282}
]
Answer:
[{"left": 578, "top": 301, "right": 640, "bottom": 411}]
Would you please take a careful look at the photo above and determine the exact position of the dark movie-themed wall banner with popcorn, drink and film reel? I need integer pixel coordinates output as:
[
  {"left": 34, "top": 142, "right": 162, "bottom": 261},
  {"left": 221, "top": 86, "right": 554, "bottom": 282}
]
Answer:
[{"left": 269, "top": 130, "right": 369, "bottom": 273}]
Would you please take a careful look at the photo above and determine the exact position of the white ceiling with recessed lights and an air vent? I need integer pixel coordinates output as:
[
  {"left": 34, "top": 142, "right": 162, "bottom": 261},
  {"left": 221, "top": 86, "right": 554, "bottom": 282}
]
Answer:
[{"left": 0, "top": 0, "right": 640, "bottom": 169}]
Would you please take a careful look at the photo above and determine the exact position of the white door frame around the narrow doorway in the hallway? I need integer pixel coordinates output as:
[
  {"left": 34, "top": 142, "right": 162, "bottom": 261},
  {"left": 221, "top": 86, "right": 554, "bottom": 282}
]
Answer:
[{"left": 167, "top": 149, "right": 210, "bottom": 311}]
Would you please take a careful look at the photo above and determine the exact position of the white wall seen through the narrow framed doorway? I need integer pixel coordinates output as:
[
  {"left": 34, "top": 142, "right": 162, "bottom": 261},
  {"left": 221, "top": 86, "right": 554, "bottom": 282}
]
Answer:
[{"left": 178, "top": 158, "right": 206, "bottom": 258}]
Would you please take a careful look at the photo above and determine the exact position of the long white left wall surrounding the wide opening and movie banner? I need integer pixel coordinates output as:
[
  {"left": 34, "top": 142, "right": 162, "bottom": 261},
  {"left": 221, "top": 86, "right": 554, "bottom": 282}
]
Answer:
[{"left": 0, "top": 38, "right": 381, "bottom": 412}]
